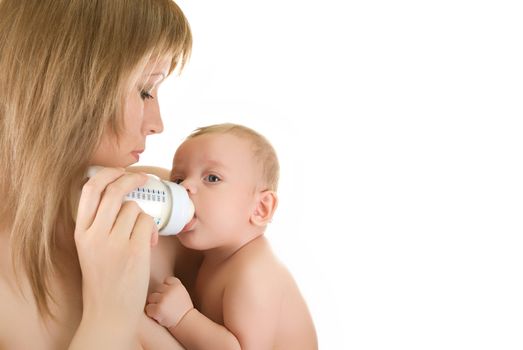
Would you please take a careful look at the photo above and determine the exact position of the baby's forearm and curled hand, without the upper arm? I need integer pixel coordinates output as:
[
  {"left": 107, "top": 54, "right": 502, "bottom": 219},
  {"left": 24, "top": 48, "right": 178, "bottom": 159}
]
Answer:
[{"left": 145, "top": 277, "right": 240, "bottom": 350}]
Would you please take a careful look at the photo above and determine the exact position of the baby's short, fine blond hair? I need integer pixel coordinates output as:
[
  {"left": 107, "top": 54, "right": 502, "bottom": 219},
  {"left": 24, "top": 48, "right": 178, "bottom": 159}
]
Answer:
[{"left": 187, "top": 123, "right": 280, "bottom": 192}]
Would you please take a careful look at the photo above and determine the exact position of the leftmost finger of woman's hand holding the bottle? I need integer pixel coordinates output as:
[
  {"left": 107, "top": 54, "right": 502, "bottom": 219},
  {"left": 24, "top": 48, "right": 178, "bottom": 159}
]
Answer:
[{"left": 76, "top": 168, "right": 125, "bottom": 232}]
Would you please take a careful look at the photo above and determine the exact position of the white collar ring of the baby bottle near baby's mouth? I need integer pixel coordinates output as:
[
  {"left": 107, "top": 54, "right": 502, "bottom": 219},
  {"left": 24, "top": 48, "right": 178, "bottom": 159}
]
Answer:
[{"left": 160, "top": 181, "right": 194, "bottom": 235}]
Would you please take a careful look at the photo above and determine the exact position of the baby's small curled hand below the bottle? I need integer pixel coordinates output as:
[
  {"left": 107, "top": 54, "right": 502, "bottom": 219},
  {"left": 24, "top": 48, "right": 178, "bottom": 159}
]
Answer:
[{"left": 145, "top": 276, "right": 194, "bottom": 328}]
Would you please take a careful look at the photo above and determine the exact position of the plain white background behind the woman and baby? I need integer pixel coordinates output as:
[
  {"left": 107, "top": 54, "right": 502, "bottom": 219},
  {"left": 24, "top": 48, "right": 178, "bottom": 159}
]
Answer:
[{"left": 140, "top": 0, "right": 523, "bottom": 350}]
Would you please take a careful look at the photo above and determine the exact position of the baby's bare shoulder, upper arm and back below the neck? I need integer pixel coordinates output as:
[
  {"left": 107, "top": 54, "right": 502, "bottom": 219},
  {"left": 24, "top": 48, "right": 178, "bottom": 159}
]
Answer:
[{"left": 222, "top": 240, "right": 317, "bottom": 349}]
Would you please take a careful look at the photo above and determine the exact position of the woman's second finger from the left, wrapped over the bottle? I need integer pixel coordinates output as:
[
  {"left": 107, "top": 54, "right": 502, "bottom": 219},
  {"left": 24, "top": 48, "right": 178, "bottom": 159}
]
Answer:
[{"left": 92, "top": 173, "right": 147, "bottom": 232}]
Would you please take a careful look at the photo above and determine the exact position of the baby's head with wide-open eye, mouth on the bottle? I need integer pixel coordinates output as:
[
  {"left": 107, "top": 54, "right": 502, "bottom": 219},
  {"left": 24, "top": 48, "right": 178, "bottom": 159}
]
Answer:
[{"left": 171, "top": 124, "right": 279, "bottom": 250}]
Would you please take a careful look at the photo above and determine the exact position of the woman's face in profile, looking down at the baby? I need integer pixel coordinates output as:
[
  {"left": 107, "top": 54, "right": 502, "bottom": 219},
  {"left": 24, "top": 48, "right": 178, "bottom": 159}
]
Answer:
[{"left": 89, "top": 58, "right": 171, "bottom": 168}]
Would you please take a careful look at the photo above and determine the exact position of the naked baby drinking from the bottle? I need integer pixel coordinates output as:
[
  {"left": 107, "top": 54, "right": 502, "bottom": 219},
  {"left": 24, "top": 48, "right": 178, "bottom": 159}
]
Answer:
[{"left": 146, "top": 124, "right": 318, "bottom": 350}]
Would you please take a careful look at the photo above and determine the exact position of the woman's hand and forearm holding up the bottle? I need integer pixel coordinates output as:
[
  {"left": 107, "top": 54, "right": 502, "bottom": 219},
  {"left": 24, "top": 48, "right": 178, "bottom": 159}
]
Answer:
[{"left": 72, "top": 168, "right": 158, "bottom": 349}]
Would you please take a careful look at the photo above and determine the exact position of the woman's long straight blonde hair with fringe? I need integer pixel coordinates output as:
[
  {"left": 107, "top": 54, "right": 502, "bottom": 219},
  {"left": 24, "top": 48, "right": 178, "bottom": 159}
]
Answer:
[{"left": 0, "top": 0, "right": 192, "bottom": 317}]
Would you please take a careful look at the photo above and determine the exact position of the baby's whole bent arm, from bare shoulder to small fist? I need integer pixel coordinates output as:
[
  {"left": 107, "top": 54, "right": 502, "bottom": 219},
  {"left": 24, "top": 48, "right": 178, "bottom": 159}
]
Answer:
[{"left": 146, "top": 270, "right": 283, "bottom": 350}]
